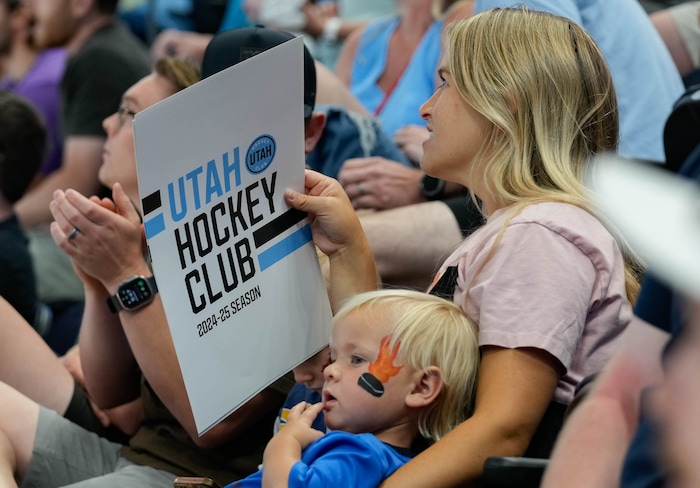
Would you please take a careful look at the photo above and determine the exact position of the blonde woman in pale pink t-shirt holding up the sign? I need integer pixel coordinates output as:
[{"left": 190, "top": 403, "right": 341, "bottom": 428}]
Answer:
[{"left": 287, "top": 9, "right": 639, "bottom": 487}]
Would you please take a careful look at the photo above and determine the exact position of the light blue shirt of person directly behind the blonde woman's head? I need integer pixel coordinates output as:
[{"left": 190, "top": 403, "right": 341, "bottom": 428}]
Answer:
[{"left": 474, "top": 0, "right": 684, "bottom": 161}]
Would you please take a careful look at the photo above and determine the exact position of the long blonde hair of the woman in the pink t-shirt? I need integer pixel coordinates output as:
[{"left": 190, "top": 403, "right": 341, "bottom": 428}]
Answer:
[{"left": 446, "top": 8, "right": 641, "bottom": 301}]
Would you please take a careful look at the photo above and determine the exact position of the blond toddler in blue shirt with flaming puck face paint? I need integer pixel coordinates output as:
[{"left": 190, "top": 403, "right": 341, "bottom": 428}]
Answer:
[{"left": 230, "top": 290, "right": 479, "bottom": 487}]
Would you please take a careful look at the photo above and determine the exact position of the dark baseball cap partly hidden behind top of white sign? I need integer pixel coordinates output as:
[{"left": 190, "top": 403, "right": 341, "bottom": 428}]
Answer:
[{"left": 202, "top": 26, "right": 316, "bottom": 117}]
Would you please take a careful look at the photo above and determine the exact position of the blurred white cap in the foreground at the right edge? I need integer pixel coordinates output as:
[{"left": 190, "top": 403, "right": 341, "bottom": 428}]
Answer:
[{"left": 589, "top": 152, "right": 700, "bottom": 299}]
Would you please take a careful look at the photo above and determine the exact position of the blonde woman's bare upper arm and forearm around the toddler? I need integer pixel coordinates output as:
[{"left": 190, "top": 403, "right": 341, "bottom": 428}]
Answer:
[{"left": 382, "top": 347, "right": 562, "bottom": 488}]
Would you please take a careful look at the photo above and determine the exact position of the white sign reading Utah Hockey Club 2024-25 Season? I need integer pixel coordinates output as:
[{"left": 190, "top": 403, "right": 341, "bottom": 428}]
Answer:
[{"left": 134, "top": 38, "right": 331, "bottom": 435}]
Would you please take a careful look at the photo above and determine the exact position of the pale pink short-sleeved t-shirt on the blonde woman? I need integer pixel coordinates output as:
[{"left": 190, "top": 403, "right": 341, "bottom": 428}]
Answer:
[{"left": 436, "top": 202, "right": 632, "bottom": 404}]
